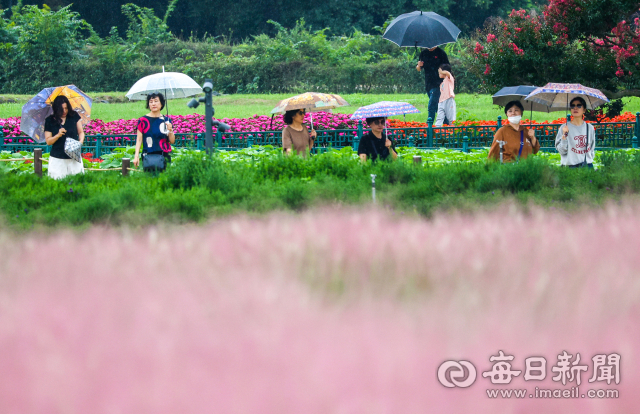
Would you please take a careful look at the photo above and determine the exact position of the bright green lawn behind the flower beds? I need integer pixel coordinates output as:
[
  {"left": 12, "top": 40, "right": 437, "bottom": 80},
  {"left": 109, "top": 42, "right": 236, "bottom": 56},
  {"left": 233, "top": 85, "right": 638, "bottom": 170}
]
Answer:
[{"left": 0, "top": 92, "right": 640, "bottom": 122}]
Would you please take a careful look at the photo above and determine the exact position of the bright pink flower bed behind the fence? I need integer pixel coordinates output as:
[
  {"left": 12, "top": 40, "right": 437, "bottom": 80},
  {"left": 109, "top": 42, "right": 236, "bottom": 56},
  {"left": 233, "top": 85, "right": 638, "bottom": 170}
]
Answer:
[{"left": 0, "top": 112, "right": 357, "bottom": 143}]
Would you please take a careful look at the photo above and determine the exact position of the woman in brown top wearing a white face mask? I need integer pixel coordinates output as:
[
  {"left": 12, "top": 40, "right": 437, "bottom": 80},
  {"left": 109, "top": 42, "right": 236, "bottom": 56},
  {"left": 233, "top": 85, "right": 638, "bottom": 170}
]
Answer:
[{"left": 488, "top": 101, "right": 540, "bottom": 162}]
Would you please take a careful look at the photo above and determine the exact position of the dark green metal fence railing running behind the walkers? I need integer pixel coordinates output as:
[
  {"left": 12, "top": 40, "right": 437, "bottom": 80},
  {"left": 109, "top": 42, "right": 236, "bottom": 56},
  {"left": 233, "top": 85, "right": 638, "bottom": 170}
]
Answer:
[{"left": 0, "top": 112, "right": 640, "bottom": 158}]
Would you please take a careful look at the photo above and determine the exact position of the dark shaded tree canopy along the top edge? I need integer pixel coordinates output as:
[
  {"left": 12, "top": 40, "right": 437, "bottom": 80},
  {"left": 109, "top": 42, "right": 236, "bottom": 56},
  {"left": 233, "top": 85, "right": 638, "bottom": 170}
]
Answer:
[{"left": 0, "top": 0, "right": 546, "bottom": 41}]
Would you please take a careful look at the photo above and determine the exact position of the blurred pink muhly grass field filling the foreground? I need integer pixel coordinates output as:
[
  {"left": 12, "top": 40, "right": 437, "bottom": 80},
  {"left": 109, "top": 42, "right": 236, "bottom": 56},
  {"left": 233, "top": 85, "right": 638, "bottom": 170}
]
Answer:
[{"left": 0, "top": 206, "right": 640, "bottom": 414}]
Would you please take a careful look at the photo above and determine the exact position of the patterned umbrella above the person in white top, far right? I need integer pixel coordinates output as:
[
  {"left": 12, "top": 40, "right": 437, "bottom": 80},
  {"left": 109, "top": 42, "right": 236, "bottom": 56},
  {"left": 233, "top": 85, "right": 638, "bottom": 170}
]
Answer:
[{"left": 524, "top": 83, "right": 609, "bottom": 111}]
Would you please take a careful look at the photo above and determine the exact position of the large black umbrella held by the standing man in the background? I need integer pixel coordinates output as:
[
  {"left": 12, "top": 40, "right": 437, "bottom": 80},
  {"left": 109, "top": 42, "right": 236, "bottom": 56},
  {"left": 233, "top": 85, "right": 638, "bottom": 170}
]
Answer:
[{"left": 382, "top": 11, "right": 460, "bottom": 48}]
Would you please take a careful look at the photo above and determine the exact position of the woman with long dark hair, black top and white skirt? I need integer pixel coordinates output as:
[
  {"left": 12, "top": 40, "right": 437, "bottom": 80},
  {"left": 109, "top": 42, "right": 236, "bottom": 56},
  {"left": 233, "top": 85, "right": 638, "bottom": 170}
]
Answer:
[{"left": 44, "top": 95, "right": 84, "bottom": 179}]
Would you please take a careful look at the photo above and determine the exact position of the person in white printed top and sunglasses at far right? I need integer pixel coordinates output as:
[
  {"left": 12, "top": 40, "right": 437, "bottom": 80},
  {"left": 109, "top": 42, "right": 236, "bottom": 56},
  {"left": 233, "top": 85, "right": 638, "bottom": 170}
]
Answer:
[{"left": 556, "top": 98, "right": 596, "bottom": 168}]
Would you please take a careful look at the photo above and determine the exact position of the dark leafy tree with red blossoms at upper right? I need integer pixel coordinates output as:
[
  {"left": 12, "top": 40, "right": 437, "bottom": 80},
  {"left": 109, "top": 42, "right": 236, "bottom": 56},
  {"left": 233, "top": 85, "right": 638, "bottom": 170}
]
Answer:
[{"left": 469, "top": 0, "right": 640, "bottom": 99}]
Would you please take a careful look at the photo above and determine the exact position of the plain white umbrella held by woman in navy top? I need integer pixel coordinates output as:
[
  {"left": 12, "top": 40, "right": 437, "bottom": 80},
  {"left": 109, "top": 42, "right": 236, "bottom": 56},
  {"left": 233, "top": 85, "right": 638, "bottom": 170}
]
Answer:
[{"left": 125, "top": 66, "right": 202, "bottom": 113}]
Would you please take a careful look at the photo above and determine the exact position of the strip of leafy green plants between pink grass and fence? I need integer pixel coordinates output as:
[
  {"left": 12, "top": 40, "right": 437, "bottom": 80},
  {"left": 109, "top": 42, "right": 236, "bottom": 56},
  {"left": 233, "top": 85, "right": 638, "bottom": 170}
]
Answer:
[{"left": 0, "top": 148, "right": 640, "bottom": 228}]
